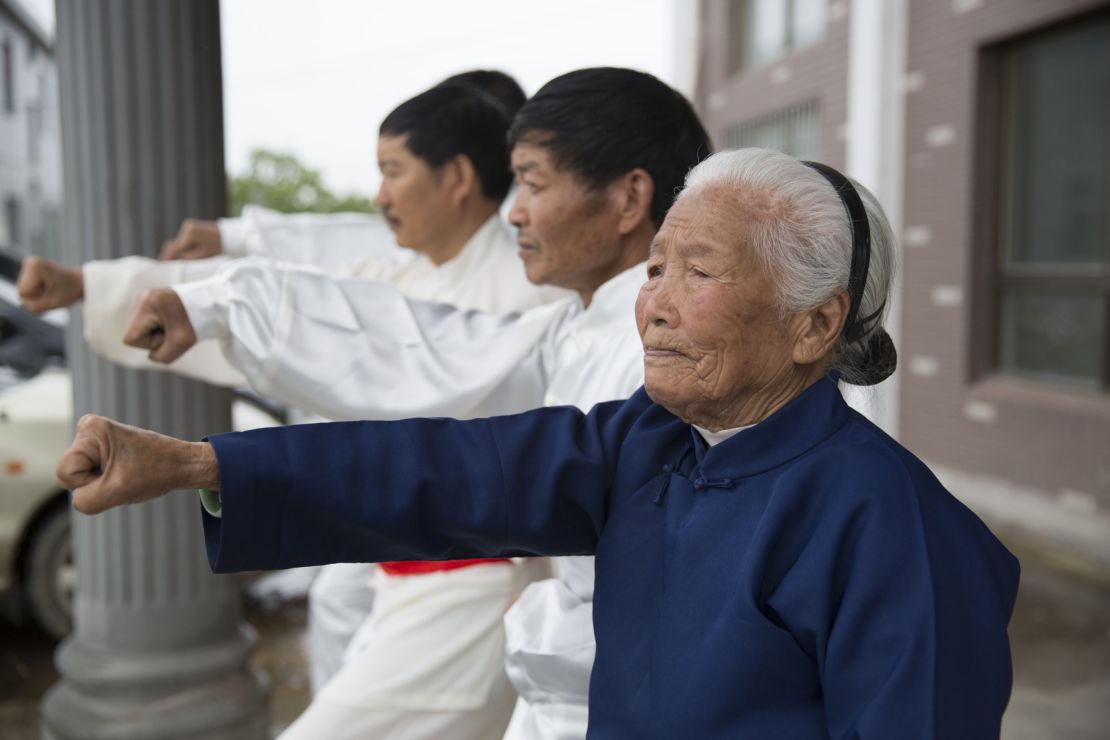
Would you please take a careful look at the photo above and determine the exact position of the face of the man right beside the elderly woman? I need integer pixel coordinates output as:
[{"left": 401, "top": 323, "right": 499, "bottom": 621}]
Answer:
[{"left": 508, "top": 143, "right": 620, "bottom": 292}]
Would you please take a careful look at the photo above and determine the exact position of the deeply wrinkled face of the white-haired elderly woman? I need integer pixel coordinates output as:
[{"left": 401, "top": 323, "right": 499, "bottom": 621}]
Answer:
[{"left": 636, "top": 186, "right": 795, "bottom": 429}]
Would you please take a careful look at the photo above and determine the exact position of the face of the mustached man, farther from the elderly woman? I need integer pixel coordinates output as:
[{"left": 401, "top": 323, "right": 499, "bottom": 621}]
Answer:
[{"left": 376, "top": 134, "right": 453, "bottom": 252}]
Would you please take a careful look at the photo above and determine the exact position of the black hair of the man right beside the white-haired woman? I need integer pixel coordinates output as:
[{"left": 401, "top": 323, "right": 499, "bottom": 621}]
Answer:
[{"left": 508, "top": 67, "right": 712, "bottom": 226}]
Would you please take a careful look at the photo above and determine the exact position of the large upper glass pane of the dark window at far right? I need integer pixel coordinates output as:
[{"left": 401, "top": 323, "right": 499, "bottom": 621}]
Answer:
[{"left": 1003, "top": 20, "right": 1110, "bottom": 265}]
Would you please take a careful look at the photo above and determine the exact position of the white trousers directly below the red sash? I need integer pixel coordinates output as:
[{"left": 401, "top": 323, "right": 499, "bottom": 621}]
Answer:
[{"left": 281, "top": 562, "right": 527, "bottom": 740}]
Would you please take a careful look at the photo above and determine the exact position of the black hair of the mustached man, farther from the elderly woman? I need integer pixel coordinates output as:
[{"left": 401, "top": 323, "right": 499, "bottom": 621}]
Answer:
[{"left": 379, "top": 82, "right": 513, "bottom": 201}]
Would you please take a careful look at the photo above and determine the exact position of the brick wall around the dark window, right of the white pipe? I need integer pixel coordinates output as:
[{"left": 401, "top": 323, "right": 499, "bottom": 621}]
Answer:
[{"left": 900, "top": 0, "right": 1110, "bottom": 507}]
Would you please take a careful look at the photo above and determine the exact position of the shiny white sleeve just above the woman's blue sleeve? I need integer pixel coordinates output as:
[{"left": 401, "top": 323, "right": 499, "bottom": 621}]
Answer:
[{"left": 174, "top": 259, "right": 576, "bottom": 420}]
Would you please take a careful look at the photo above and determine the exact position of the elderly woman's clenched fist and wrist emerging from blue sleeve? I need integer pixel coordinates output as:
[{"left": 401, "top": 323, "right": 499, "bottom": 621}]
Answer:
[{"left": 56, "top": 415, "right": 220, "bottom": 514}]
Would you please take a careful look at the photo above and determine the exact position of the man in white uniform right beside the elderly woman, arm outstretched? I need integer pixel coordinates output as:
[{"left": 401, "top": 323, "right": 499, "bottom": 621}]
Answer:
[{"left": 119, "top": 69, "right": 709, "bottom": 740}]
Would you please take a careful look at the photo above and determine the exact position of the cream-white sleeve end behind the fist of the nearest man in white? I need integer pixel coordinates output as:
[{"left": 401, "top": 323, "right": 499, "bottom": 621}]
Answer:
[{"left": 82, "top": 257, "right": 246, "bottom": 387}]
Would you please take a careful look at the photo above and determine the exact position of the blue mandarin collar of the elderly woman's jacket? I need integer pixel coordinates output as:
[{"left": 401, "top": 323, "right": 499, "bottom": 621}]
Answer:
[{"left": 690, "top": 375, "right": 851, "bottom": 478}]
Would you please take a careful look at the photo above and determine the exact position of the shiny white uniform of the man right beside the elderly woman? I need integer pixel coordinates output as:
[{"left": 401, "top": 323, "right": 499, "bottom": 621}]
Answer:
[{"left": 167, "top": 257, "right": 645, "bottom": 739}]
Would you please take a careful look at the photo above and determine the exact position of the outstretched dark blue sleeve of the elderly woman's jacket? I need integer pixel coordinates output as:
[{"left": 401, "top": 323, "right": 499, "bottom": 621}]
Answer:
[{"left": 203, "top": 402, "right": 634, "bottom": 572}]
